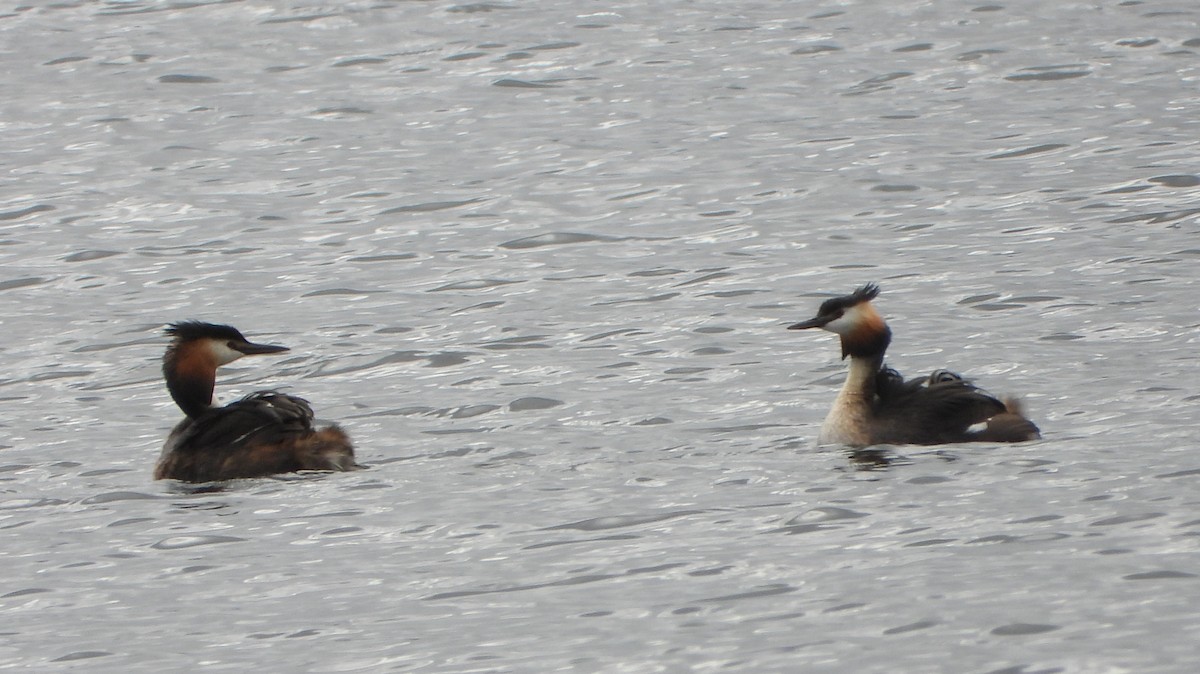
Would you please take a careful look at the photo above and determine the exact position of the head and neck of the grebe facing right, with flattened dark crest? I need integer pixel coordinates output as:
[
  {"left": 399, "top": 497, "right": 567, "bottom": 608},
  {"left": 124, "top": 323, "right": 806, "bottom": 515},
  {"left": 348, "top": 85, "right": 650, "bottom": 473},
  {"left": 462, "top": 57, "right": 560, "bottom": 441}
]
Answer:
[{"left": 162, "top": 320, "right": 288, "bottom": 416}]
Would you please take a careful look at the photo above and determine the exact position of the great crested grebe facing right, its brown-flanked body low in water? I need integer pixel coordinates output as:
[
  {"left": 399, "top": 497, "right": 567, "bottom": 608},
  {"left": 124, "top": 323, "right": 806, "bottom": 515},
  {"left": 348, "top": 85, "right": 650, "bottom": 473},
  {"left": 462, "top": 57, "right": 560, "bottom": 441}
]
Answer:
[{"left": 154, "top": 320, "right": 359, "bottom": 482}]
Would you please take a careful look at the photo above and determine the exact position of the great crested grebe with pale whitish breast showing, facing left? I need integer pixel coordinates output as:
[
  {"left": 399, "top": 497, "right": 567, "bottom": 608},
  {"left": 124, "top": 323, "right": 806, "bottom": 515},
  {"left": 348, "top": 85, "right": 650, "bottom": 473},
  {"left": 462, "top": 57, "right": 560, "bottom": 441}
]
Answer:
[{"left": 788, "top": 283, "right": 1040, "bottom": 447}]
